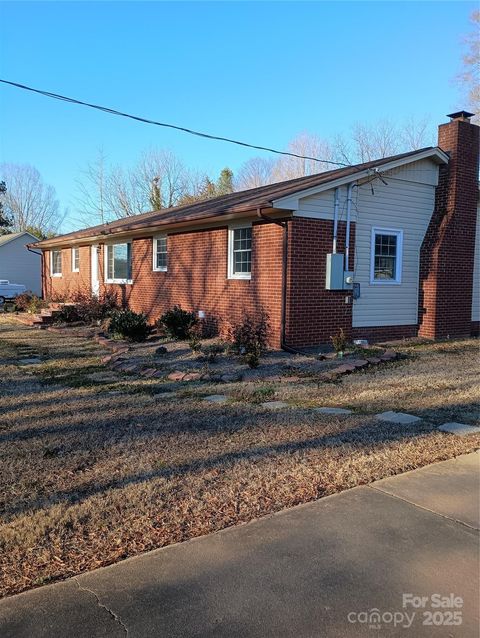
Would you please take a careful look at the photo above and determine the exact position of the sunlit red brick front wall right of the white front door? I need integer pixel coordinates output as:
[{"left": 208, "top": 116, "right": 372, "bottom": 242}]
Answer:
[{"left": 89, "top": 223, "right": 283, "bottom": 347}]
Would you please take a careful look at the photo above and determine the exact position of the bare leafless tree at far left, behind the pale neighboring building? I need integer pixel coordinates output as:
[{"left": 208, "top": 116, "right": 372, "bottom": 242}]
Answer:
[{"left": 0, "top": 163, "right": 65, "bottom": 233}]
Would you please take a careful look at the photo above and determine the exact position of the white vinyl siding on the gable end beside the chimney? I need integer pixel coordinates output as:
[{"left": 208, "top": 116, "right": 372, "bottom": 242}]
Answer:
[{"left": 294, "top": 160, "right": 438, "bottom": 328}]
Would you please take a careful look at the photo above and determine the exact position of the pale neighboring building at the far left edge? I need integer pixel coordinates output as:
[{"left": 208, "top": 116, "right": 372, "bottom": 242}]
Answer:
[{"left": 0, "top": 231, "right": 42, "bottom": 295}]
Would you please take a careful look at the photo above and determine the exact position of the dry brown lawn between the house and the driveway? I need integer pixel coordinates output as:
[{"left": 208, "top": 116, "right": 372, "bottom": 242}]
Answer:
[{"left": 0, "top": 317, "right": 480, "bottom": 595}]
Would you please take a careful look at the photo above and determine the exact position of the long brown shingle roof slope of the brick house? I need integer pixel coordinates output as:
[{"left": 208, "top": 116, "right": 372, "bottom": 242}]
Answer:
[{"left": 31, "top": 146, "right": 440, "bottom": 248}]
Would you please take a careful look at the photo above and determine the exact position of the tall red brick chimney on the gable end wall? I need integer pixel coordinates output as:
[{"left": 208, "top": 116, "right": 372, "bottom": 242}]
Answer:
[{"left": 418, "top": 111, "right": 480, "bottom": 339}]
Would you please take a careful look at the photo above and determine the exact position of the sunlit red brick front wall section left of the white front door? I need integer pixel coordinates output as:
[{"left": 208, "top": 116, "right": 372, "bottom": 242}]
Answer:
[{"left": 42, "top": 246, "right": 91, "bottom": 300}]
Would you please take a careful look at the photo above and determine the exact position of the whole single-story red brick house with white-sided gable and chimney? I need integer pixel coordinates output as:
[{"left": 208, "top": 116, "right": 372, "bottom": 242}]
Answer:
[{"left": 35, "top": 111, "right": 480, "bottom": 347}]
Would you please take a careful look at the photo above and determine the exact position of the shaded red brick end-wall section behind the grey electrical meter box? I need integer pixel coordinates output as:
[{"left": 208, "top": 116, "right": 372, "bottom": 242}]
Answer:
[{"left": 286, "top": 217, "right": 355, "bottom": 347}]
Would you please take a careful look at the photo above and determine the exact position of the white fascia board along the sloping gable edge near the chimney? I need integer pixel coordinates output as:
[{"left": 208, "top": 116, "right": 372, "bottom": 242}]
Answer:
[{"left": 272, "top": 147, "right": 449, "bottom": 210}]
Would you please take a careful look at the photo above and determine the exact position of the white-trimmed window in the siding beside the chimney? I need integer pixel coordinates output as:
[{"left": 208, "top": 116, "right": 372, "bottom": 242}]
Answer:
[{"left": 370, "top": 228, "right": 403, "bottom": 284}]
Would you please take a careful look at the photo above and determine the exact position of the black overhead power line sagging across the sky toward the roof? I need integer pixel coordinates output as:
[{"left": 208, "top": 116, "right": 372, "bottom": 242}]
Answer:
[{"left": 0, "top": 79, "right": 351, "bottom": 166}]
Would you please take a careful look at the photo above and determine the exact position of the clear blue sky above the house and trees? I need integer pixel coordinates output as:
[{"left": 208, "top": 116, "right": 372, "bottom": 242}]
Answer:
[{"left": 0, "top": 2, "right": 476, "bottom": 230}]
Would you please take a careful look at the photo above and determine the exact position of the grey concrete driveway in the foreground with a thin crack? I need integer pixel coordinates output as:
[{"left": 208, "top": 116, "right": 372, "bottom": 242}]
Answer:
[{"left": 0, "top": 453, "right": 480, "bottom": 638}]
